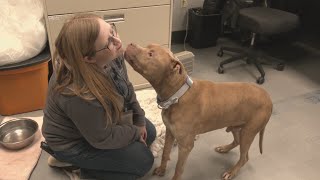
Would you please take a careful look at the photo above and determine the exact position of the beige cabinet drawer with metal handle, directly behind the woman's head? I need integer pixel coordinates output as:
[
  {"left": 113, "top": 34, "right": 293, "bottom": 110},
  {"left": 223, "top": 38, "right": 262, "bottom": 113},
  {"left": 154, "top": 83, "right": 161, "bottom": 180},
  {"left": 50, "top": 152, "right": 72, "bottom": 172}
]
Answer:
[{"left": 48, "top": 5, "right": 170, "bottom": 52}]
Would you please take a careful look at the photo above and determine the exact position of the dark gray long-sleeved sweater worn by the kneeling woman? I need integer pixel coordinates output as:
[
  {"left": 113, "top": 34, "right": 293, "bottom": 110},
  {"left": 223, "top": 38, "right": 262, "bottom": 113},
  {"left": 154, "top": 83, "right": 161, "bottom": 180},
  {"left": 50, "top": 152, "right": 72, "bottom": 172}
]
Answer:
[{"left": 42, "top": 57, "right": 145, "bottom": 151}]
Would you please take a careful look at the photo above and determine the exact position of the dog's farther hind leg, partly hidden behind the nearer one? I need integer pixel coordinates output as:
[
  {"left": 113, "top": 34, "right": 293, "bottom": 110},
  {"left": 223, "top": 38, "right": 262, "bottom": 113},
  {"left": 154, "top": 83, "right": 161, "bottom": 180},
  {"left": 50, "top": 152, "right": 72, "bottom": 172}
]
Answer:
[{"left": 215, "top": 127, "right": 241, "bottom": 153}]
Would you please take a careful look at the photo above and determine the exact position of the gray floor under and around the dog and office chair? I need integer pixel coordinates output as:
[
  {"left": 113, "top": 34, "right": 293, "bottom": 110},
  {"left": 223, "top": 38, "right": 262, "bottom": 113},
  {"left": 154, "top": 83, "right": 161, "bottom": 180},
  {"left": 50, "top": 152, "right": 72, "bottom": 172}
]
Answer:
[{"left": 30, "top": 39, "right": 320, "bottom": 180}]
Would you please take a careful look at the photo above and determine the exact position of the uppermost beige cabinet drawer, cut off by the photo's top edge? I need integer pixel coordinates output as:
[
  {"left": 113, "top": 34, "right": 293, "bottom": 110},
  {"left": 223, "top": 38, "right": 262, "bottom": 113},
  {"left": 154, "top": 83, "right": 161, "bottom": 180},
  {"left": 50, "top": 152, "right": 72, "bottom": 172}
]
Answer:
[{"left": 45, "top": 0, "right": 170, "bottom": 15}]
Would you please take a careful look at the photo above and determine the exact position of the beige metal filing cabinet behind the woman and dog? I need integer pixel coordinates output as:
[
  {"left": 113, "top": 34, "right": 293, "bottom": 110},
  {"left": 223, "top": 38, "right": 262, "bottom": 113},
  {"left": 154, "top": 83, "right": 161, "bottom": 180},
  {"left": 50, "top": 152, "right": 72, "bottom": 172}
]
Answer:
[{"left": 44, "top": 0, "right": 173, "bottom": 89}]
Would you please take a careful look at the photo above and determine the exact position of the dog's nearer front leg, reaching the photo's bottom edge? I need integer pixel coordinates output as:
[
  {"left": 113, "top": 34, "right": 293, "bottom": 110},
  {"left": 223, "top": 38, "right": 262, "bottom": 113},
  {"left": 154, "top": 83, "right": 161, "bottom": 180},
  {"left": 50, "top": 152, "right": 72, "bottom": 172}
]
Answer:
[{"left": 172, "top": 135, "right": 195, "bottom": 180}]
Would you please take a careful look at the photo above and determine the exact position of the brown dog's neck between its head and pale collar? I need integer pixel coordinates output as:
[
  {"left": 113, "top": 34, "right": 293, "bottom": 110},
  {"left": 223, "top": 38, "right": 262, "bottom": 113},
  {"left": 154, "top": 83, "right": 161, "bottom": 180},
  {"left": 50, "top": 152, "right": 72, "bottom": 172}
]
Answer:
[{"left": 152, "top": 71, "right": 188, "bottom": 105}]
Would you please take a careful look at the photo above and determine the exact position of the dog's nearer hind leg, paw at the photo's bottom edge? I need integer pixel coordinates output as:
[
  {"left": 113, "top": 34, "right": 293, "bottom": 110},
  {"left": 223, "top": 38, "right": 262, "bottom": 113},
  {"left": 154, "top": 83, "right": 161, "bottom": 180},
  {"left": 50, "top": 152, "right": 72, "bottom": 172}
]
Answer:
[{"left": 222, "top": 126, "right": 257, "bottom": 180}]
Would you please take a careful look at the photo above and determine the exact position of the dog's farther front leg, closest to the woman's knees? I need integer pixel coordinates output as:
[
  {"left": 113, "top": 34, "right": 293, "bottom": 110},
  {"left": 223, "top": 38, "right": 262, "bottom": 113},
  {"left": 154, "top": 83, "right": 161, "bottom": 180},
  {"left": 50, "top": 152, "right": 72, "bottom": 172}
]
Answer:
[{"left": 153, "top": 128, "right": 175, "bottom": 176}]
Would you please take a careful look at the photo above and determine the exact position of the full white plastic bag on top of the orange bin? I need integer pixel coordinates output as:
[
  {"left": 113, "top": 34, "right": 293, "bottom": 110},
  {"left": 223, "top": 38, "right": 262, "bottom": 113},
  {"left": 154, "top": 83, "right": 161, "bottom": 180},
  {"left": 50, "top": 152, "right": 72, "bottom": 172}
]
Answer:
[{"left": 0, "top": 0, "right": 47, "bottom": 66}]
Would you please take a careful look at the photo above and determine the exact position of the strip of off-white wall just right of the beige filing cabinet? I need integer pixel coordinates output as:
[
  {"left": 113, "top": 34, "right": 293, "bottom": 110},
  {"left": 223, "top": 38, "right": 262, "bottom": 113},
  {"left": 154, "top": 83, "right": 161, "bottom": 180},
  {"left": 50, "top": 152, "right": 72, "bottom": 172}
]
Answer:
[{"left": 172, "top": 0, "right": 204, "bottom": 31}]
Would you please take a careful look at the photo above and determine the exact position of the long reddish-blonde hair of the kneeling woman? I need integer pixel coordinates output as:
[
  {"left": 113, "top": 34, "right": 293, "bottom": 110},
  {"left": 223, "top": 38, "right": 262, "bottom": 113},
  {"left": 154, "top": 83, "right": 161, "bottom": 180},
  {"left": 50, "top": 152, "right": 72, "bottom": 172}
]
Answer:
[{"left": 52, "top": 14, "right": 121, "bottom": 124}]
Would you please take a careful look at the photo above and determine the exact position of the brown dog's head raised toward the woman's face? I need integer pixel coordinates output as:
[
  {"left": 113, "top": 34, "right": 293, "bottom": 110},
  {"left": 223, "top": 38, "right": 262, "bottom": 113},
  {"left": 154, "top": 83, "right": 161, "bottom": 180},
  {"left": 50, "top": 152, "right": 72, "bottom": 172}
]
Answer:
[{"left": 125, "top": 44, "right": 185, "bottom": 83}]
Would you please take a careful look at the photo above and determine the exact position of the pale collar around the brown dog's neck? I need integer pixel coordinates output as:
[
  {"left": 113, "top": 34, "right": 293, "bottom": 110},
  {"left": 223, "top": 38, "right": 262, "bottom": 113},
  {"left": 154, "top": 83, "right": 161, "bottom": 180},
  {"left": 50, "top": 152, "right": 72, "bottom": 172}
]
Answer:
[{"left": 157, "top": 76, "right": 193, "bottom": 109}]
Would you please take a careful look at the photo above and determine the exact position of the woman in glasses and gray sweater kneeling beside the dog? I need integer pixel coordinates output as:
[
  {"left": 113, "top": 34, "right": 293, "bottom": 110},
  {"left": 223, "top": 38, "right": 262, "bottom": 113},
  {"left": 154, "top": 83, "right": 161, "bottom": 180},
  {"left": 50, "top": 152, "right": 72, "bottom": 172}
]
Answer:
[{"left": 42, "top": 14, "right": 156, "bottom": 180}]
